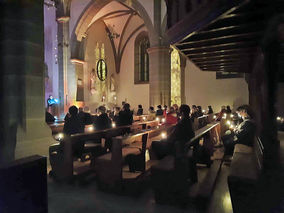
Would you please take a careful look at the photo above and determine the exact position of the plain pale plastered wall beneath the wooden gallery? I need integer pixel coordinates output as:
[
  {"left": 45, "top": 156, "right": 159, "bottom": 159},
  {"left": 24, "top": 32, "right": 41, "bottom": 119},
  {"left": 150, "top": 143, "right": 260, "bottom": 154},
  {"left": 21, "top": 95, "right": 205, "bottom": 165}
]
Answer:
[{"left": 185, "top": 60, "right": 249, "bottom": 112}]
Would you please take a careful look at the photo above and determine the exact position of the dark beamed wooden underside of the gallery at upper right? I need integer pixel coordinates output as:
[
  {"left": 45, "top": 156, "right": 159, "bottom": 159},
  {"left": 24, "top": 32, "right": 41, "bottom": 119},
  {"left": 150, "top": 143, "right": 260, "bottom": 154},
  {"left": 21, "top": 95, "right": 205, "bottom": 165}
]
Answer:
[{"left": 173, "top": 0, "right": 284, "bottom": 73}]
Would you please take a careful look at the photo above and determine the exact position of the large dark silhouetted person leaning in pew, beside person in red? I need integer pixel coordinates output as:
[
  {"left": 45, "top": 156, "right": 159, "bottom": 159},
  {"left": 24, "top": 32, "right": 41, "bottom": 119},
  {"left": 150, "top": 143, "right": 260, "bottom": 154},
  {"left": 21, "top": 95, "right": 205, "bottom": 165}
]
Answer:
[{"left": 152, "top": 104, "right": 195, "bottom": 159}]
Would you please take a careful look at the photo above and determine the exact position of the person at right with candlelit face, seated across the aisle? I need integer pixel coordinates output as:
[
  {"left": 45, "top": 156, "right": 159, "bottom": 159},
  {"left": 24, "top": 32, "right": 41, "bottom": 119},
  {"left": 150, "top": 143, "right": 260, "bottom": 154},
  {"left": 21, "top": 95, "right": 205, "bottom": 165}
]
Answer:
[{"left": 222, "top": 105, "right": 256, "bottom": 155}]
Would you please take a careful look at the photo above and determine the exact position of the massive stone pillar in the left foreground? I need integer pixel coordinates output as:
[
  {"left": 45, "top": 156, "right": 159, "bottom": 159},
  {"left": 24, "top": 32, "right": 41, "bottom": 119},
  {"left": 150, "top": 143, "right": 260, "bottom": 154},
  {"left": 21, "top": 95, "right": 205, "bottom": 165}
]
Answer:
[{"left": 0, "top": 0, "right": 54, "bottom": 163}]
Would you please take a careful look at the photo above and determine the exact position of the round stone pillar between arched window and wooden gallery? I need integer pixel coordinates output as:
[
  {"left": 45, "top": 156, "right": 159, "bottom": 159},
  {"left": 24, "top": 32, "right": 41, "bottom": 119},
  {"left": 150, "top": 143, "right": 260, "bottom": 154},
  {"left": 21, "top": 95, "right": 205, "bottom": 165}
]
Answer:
[{"left": 148, "top": 46, "right": 171, "bottom": 107}]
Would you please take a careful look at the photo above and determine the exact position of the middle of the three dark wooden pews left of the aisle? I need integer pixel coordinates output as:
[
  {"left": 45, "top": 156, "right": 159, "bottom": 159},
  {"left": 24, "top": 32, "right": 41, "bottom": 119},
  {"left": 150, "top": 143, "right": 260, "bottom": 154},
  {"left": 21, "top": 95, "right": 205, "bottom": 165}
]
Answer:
[{"left": 95, "top": 125, "right": 173, "bottom": 188}]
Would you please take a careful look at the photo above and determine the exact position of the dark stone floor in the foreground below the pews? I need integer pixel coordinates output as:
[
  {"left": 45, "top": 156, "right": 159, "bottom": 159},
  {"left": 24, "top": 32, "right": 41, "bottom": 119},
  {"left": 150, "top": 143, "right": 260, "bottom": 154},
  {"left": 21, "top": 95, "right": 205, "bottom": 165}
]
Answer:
[{"left": 48, "top": 162, "right": 232, "bottom": 213}]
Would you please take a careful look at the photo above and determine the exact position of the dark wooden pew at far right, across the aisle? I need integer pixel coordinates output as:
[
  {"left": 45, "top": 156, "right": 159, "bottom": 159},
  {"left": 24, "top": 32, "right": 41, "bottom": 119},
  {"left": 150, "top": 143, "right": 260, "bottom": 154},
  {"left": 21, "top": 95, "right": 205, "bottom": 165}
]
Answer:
[{"left": 228, "top": 137, "right": 264, "bottom": 213}]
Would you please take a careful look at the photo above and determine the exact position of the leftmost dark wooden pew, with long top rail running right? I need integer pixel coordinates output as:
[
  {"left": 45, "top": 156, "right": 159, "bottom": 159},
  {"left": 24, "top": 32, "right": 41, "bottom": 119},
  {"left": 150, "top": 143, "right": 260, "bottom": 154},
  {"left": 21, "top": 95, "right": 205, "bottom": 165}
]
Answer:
[{"left": 49, "top": 121, "right": 161, "bottom": 179}]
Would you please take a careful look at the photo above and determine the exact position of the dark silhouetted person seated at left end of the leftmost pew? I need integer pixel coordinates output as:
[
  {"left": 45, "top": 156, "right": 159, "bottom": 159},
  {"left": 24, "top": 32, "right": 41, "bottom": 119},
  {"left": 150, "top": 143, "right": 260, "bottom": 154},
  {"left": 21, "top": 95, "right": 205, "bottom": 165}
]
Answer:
[{"left": 63, "top": 106, "right": 85, "bottom": 135}]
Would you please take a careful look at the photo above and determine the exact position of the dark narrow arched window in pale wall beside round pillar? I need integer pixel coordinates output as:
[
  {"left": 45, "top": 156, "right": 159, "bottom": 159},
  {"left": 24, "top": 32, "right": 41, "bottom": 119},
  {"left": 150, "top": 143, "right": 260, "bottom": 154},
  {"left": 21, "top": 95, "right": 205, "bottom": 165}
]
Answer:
[{"left": 134, "top": 32, "right": 150, "bottom": 84}]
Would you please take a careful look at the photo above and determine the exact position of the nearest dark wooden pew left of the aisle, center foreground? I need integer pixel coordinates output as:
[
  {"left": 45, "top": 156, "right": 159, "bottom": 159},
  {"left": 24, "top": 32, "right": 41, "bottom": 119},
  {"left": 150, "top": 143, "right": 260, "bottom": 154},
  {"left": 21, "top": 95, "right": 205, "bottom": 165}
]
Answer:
[{"left": 151, "top": 122, "right": 220, "bottom": 204}]
